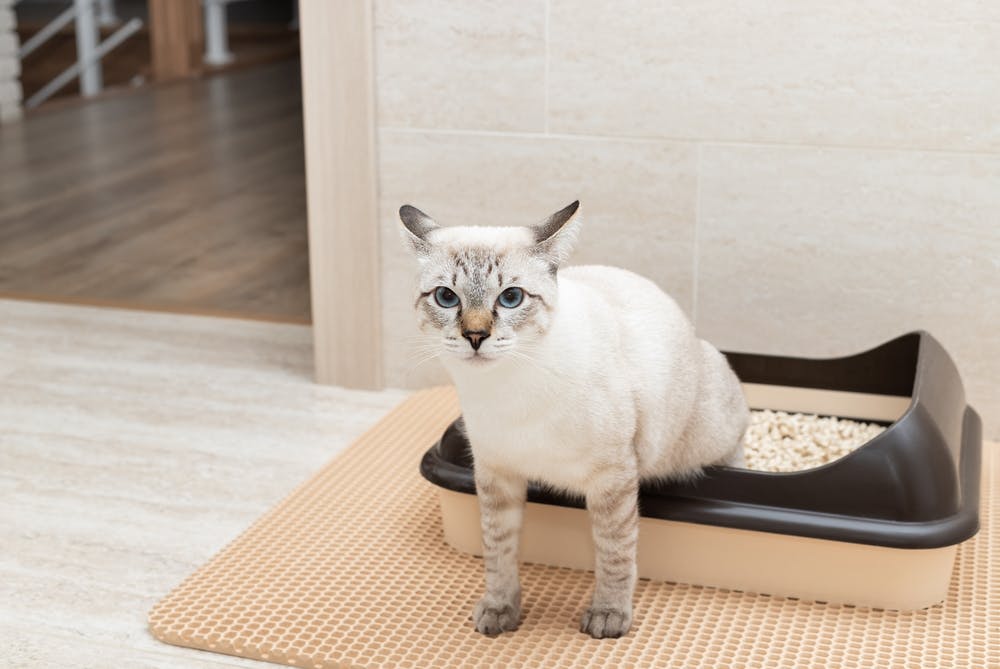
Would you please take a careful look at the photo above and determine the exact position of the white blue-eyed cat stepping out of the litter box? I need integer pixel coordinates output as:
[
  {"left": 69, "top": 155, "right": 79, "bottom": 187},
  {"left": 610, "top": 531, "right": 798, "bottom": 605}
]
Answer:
[{"left": 399, "top": 201, "right": 749, "bottom": 638}]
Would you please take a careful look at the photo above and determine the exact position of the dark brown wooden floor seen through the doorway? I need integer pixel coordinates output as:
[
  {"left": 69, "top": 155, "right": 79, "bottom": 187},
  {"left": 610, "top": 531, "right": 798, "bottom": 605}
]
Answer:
[{"left": 0, "top": 60, "right": 309, "bottom": 322}]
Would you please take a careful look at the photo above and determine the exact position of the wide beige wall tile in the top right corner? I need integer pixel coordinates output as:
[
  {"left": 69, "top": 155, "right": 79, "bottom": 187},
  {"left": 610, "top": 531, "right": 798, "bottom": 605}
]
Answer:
[{"left": 549, "top": 0, "right": 1000, "bottom": 150}]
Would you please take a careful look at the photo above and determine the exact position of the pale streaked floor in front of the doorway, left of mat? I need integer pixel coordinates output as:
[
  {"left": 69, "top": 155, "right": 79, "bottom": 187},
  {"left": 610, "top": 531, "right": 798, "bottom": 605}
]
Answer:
[{"left": 0, "top": 300, "right": 406, "bottom": 669}]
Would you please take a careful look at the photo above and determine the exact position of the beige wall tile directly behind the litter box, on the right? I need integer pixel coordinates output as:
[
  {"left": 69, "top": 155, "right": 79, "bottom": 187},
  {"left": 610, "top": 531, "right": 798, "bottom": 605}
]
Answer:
[{"left": 697, "top": 146, "right": 1000, "bottom": 438}]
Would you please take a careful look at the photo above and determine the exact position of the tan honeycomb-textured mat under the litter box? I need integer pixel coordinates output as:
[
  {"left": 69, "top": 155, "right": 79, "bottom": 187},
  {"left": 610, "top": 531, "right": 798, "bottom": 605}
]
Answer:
[{"left": 149, "top": 388, "right": 1000, "bottom": 669}]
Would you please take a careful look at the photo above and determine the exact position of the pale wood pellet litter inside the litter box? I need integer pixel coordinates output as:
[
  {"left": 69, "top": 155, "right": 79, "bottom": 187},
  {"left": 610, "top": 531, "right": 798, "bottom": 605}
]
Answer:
[{"left": 743, "top": 409, "right": 885, "bottom": 472}]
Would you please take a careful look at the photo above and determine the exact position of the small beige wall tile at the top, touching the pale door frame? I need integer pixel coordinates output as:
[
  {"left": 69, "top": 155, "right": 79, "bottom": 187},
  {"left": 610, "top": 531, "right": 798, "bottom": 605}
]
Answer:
[{"left": 375, "top": 0, "right": 545, "bottom": 131}]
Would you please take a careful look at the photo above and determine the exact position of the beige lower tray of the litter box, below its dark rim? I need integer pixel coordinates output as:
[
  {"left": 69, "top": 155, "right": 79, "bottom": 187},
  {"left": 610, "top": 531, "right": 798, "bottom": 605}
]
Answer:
[{"left": 440, "top": 489, "right": 957, "bottom": 611}]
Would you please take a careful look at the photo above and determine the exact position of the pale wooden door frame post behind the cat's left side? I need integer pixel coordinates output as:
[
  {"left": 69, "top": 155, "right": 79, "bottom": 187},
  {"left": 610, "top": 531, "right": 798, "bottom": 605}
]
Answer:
[{"left": 299, "top": 0, "right": 383, "bottom": 389}]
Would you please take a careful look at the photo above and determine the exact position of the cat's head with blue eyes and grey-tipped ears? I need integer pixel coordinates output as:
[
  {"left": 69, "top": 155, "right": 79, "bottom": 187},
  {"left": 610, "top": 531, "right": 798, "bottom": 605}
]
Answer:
[{"left": 399, "top": 201, "right": 580, "bottom": 366}]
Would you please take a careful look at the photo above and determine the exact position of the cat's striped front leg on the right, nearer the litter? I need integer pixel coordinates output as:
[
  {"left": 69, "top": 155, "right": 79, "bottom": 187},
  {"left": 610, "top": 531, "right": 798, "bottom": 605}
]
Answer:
[{"left": 580, "top": 469, "right": 639, "bottom": 639}]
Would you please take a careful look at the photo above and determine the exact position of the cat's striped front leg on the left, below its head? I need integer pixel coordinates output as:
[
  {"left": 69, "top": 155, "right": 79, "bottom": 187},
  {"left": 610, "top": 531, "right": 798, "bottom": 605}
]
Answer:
[{"left": 472, "top": 463, "right": 528, "bottom": 634}]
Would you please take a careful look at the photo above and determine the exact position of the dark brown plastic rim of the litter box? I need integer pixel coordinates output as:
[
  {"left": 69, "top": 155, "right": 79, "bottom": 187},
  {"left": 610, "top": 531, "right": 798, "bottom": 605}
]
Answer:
[{"left": 420, "top": 332, "right": 982, "bottom": 549}]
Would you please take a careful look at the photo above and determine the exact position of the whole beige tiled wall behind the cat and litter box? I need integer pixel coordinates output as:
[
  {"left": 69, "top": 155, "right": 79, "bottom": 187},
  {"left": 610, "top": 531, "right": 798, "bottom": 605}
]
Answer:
[{"left": 375, "top": 0, "right": 1000, "bottom": 437}]
